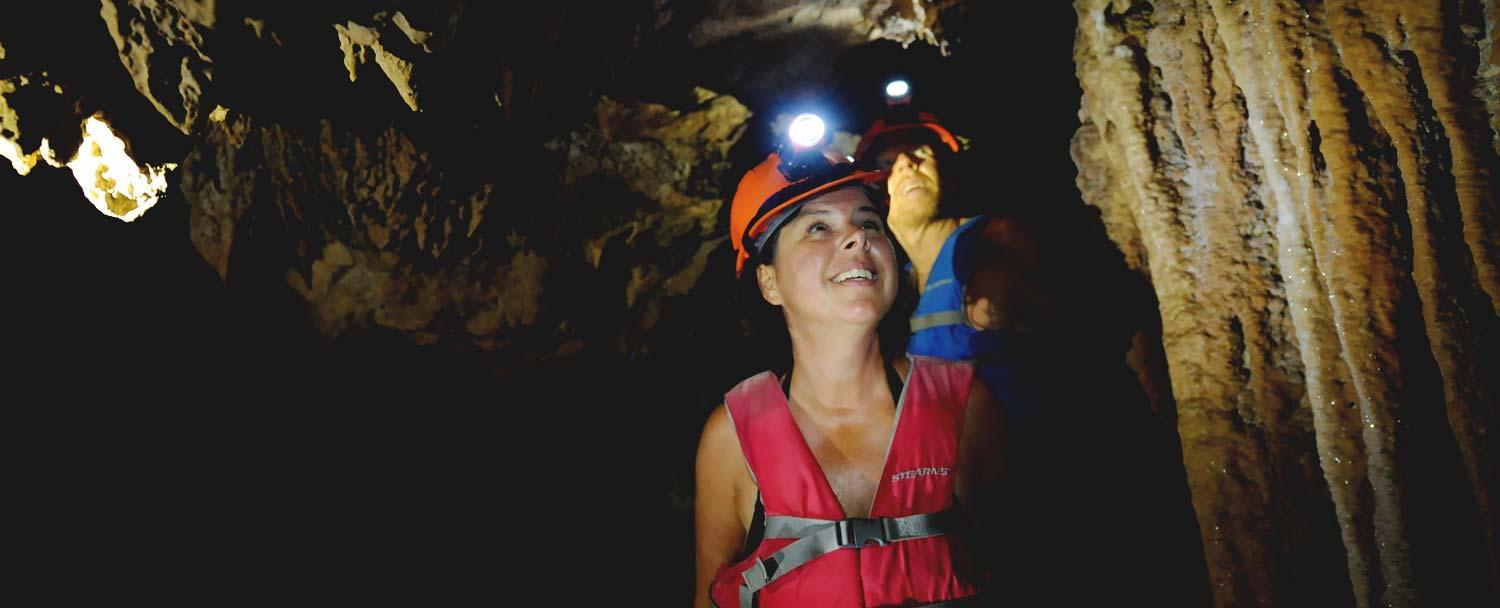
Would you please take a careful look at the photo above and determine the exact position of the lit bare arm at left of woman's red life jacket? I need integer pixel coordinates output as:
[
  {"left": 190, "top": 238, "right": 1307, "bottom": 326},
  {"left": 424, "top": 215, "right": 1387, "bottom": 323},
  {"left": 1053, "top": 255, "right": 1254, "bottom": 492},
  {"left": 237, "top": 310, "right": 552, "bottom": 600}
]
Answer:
[{"left": 693, "top": 407, "right": 753, "bottom": 608}]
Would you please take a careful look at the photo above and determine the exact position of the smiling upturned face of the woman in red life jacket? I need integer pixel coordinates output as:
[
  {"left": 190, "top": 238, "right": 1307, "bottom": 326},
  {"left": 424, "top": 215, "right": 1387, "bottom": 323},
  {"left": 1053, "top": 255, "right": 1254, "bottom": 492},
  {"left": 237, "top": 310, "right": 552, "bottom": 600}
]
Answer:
[{"left": 756, "top": 188, "right": 897, "bottom": 324}]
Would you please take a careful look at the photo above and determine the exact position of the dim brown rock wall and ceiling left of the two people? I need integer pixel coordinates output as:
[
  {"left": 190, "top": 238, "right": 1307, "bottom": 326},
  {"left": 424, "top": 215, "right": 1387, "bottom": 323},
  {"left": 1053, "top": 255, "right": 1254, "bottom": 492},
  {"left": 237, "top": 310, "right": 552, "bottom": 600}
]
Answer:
[{"left": 0, "top": 0, "right": 956, "bottom": 363}]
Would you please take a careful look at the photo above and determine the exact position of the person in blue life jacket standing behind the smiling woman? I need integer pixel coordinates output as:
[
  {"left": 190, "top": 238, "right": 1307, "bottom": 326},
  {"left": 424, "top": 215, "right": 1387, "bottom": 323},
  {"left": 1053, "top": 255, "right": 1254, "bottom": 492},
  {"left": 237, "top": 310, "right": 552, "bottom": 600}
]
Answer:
[{"left": 855, "top": 113, "right": 1056, "bottom": 429}]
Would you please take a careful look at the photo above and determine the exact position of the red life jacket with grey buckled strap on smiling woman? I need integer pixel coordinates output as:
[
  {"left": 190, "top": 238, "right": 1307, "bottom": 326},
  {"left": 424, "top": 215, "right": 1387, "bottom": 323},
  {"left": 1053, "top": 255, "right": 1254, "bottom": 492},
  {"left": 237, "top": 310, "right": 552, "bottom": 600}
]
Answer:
[{"left": 710, "top": 352, "right": 978, "bottom": 608}]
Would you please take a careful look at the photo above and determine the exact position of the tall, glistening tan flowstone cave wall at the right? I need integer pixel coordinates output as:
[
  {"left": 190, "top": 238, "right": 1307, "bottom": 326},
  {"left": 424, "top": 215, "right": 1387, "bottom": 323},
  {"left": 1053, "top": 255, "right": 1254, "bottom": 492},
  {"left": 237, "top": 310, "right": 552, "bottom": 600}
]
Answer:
[{"left": 1073, "top": 0, "right": 1500, "bottom": 606}]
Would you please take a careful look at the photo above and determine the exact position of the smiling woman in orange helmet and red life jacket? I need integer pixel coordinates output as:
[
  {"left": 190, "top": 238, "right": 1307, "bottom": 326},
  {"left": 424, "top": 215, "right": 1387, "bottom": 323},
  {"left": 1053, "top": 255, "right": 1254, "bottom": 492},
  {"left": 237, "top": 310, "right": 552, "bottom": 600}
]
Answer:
[{"left": 695, "top": 147, "right": 1002, "bottom": 608}]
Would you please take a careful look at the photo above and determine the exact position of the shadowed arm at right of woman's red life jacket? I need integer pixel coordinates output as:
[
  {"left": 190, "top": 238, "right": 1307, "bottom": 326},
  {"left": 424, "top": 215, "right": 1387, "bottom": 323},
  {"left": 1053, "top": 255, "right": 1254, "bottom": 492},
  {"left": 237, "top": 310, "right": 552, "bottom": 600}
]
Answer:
[{"left": 954, "top": 375, "right": 1005, "bottom": 576}]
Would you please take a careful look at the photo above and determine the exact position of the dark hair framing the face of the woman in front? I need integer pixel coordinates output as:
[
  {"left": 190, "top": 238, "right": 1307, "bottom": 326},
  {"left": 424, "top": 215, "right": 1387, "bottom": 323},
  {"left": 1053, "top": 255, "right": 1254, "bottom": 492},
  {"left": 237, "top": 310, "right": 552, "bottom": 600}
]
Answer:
[{"left": 737, "top": 185, "right": 917, "bottom": 374}]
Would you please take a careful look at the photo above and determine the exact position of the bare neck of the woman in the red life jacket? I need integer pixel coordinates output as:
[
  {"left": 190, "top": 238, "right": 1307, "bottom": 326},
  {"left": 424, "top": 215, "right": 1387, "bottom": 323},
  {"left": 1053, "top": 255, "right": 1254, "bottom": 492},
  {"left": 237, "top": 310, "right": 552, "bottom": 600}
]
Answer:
[{"left": 788, "top": 326, "right": 896, "bottom": 413}]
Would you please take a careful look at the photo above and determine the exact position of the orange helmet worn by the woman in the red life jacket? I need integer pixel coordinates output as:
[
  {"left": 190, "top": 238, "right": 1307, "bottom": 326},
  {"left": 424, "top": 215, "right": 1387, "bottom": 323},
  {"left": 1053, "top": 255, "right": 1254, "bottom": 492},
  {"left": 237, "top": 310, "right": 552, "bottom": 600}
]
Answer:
[{"left": 729, "top": 152, "right": 885, "bottom": 276}]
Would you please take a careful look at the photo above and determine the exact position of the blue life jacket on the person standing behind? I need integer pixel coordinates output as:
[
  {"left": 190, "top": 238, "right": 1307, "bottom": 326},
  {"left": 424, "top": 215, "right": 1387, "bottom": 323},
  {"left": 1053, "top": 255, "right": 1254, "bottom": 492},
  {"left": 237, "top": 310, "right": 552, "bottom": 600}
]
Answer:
[{"left": 906, "top": 215, "right": 1040, "bottom": 425}]
